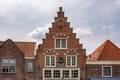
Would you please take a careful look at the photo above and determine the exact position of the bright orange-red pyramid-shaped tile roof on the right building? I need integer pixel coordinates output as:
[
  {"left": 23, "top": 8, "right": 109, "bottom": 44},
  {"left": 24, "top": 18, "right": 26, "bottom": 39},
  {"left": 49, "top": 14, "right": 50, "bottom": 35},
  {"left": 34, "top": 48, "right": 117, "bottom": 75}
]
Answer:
[{"left": 87, "top": 40, "right": 120, "bottom": 60}]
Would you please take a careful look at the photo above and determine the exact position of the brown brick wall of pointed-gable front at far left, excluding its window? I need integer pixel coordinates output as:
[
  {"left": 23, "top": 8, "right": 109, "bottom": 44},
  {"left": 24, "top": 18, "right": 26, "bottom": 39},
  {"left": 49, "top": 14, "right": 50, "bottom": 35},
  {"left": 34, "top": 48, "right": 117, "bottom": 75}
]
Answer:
[{"left": 0, "top": 40, "right": 25, "bottom": 80}]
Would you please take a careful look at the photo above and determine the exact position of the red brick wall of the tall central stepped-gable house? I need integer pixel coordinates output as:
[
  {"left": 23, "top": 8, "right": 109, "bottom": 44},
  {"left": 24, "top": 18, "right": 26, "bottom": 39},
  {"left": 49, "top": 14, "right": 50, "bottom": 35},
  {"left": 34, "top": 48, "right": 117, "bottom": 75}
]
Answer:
[{"left": 37, "top": 7, "right": 86, "bottom": 80}]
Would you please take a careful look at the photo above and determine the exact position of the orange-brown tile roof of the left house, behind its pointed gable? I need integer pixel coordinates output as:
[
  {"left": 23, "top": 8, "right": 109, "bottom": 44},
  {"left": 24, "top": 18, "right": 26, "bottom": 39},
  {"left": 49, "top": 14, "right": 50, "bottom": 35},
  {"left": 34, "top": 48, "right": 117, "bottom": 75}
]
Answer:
[{"left": 0, "top": 41, "right": 36, "bottom": 57}]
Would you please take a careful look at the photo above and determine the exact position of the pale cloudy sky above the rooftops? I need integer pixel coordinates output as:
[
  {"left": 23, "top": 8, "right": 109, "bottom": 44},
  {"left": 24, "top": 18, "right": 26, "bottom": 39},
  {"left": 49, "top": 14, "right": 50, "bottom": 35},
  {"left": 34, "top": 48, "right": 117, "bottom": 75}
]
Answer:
[{"left": 0, "top": 0, "right": 120, "bottom": 55}]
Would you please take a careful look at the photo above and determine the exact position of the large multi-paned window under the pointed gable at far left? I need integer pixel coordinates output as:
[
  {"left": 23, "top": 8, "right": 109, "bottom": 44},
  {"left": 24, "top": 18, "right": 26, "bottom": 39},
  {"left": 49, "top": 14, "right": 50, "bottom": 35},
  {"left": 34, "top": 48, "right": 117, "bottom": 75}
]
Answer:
[{"left": 2, "top": 59, "right": 16, "bottom": 73}]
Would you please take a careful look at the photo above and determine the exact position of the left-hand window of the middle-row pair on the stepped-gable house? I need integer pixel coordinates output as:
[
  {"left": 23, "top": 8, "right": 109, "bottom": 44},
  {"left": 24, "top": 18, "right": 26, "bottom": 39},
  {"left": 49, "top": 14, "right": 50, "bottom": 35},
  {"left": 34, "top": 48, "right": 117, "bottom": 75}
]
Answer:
[{"left": 45, "top": 55, "right": 55, "bottom": 67}]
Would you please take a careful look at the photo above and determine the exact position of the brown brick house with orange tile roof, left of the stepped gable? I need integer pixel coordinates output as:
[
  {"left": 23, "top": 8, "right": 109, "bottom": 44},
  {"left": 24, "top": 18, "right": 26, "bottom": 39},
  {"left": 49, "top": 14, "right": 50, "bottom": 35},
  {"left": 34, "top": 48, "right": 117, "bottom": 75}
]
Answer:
[{"left": 0, "top": 39, "right": 36, "bottom": 80}]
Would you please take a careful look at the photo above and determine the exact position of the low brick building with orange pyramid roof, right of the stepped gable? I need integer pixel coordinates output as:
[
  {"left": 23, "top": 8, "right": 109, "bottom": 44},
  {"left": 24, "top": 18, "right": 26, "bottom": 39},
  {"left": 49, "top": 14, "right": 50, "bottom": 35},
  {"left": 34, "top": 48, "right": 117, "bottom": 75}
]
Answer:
[{"left": 86, "top": 40, "right": 120, "bottom": 80}]
